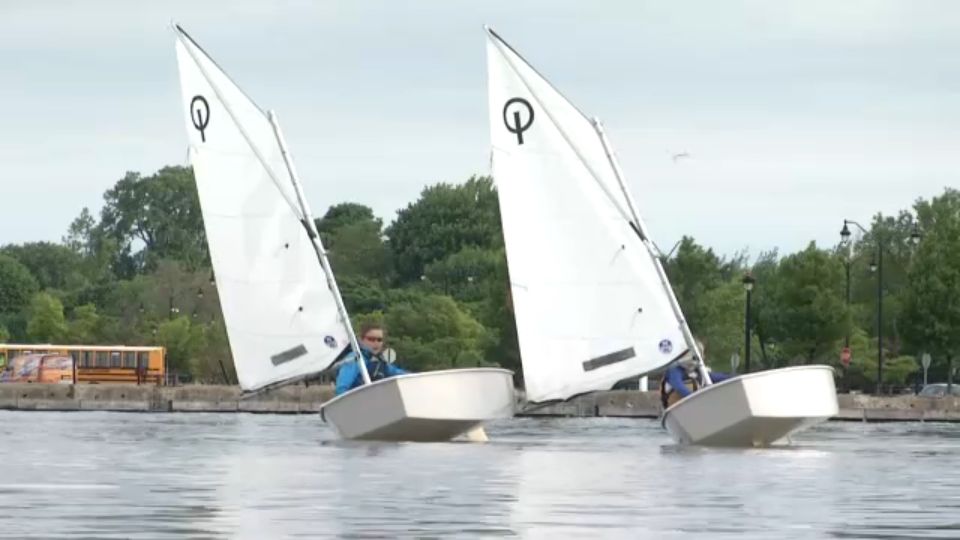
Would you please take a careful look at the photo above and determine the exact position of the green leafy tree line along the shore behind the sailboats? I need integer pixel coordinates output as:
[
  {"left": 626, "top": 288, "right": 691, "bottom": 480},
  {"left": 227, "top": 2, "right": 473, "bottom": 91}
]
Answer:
[{"left": 0, "top": 166, "right": 960, "bottom": 389}]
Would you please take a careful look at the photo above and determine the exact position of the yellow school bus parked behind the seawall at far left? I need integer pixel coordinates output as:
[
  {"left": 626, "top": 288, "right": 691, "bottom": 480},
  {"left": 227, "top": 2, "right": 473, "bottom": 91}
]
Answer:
[{"left": 0, "top": 343, "right": 166, "bottom": 385}]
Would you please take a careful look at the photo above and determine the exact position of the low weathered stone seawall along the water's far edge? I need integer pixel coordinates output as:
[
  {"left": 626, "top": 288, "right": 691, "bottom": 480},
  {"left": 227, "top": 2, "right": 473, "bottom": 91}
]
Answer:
[{"left": 0, "top": 384, "right": 960, "bottom": 422}]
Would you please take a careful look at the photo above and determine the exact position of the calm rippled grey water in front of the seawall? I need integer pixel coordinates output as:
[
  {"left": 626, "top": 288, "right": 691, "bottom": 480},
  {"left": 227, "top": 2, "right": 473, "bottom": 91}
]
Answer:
[{"left": 0, "top": 412, "right": 960, "bottom": 539}]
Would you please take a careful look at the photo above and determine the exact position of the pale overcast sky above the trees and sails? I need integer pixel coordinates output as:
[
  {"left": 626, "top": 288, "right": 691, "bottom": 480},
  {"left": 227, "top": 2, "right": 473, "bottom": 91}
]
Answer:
[{"left": 0, "top": 0, "right": 960, "bottom": 256}]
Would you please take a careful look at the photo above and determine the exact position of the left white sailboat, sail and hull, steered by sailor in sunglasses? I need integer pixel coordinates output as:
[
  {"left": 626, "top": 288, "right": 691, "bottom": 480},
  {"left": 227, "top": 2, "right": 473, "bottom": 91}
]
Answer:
[{"left": 173, "top": 25, "right": 514, "bottom": 441}]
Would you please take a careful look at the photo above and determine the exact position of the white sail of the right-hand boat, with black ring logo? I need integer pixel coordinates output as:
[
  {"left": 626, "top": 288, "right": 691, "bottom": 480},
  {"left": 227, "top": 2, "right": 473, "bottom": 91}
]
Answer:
[{"left": 487, "top": 30, "right": 688, "bottom": 402}]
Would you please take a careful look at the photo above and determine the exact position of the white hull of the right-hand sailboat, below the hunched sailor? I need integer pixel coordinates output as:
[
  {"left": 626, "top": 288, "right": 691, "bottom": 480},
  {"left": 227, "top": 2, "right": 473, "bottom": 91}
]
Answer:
[{"left": 661, "top": 365, "right": 839, "bottom": 447}]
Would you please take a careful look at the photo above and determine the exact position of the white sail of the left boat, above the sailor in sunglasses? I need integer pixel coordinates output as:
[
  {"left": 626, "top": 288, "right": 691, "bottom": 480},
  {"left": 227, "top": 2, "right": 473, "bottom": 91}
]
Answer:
[{"left": 175, "top": 27, "right": 349, "bottom": 391}]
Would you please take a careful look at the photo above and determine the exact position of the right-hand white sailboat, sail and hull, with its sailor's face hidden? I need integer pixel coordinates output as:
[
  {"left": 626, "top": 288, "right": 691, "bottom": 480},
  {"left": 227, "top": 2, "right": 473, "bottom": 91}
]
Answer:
[{"left": 486, "top": 28, "right": 837, "bottom": 445}]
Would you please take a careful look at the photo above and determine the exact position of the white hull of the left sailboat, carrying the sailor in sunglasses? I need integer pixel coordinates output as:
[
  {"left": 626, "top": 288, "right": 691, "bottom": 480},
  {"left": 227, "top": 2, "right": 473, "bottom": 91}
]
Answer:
[{"left": 320, "top": 368, "right": 516, "bottom": 442}]
